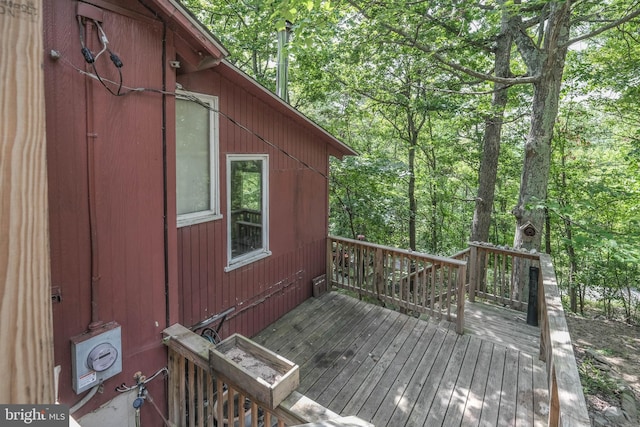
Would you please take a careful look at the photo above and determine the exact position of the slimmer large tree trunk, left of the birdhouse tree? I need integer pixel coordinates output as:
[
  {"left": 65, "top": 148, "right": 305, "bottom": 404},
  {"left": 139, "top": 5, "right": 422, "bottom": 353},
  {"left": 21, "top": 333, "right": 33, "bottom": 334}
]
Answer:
[{"left": 471, "top": 0, "right": 513, "bottom": 244}]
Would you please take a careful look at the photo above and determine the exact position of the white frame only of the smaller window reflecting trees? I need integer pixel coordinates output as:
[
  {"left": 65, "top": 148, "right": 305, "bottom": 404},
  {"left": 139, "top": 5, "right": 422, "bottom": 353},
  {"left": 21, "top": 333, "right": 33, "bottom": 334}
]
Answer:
[{"left": 224, "top": 154, "right": 271, "bottom": 272}]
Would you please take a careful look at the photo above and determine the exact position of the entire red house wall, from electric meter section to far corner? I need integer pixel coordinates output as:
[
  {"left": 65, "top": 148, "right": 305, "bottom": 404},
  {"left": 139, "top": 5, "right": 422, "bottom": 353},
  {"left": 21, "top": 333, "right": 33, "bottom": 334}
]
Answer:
[{"left": 43, "top": 0, "right": 336, "bottom": 425}]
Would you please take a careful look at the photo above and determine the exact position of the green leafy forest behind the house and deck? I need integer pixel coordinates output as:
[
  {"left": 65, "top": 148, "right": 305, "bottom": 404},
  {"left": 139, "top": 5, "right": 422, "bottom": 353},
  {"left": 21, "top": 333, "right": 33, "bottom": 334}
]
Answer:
[{"left": 183, "top": 0, "right": 640, "bottom": 324}]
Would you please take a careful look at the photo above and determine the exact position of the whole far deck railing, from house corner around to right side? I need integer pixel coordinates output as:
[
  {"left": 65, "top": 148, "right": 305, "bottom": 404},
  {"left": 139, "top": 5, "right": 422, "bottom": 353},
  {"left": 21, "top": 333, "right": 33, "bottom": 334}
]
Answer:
[{"left": 327, "top": 236, "right": 590, "bottom": 427}]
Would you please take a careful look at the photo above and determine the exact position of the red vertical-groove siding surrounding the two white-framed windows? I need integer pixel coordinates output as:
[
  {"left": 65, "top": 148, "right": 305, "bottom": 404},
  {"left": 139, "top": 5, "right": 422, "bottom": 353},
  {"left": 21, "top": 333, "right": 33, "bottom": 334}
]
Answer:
[{"left": 177, "top": 68, "right": 328, "bottom": 336}]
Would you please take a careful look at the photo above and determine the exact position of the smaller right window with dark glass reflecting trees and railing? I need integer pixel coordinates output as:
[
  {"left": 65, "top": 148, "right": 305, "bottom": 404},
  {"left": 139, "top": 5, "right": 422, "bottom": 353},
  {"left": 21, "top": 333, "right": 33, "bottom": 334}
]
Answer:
[{"left": 226, "top": 154, "right": 271, "bottom": 271}]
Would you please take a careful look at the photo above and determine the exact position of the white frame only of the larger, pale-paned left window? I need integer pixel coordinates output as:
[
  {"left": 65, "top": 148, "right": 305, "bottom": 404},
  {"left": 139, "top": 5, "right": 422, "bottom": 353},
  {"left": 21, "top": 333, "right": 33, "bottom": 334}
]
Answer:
[{"left": 176, "top": 91, "right": 222, "bottom": 227}]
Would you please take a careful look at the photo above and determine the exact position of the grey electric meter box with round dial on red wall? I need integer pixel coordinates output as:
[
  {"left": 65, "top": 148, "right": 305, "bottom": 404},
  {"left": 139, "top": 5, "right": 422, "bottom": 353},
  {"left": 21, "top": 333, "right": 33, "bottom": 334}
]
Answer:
[{"left": 71, "top": 322, "right": 122, "bottom": 394}]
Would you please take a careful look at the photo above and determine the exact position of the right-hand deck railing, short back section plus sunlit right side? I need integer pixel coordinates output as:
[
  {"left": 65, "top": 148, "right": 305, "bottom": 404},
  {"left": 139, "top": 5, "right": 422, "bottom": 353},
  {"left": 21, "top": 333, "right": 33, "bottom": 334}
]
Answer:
[{"left": 454, "top": 242, "right": 591, "bottom": 427}]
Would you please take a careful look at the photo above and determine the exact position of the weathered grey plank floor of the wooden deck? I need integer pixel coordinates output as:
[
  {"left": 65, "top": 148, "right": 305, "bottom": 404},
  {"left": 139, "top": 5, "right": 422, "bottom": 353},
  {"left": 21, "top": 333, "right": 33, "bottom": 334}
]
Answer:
[{"left": 253, "top": 292, "right": 548, "bottom": 427}]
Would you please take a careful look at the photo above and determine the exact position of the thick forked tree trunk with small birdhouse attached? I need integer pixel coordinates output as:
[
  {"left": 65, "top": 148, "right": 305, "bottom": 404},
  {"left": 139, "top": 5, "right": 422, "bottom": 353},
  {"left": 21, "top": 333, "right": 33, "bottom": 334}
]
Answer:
[{"left": 513, "top": 0, "right": 571, "bottom": 250}]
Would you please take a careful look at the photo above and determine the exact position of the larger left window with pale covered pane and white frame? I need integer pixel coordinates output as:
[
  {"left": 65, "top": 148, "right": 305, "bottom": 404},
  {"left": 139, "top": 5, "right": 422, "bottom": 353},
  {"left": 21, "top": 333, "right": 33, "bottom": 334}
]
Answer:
[{"left": 176, "top": 94, "right": 221, "bottom": 227}]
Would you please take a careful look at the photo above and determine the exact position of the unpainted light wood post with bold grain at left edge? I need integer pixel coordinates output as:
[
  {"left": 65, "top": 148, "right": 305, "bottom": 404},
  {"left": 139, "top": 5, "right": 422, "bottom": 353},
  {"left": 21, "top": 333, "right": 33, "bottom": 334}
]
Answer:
[{"left": 0, "top": 0, "right": 55, "bottom": 404}]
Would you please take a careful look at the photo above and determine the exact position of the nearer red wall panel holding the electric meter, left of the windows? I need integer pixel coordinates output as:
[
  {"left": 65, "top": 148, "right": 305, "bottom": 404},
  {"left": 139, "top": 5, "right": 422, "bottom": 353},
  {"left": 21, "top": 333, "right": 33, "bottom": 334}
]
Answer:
[{"left": 44, "top": 0, "right": 172, "bottom": 420}]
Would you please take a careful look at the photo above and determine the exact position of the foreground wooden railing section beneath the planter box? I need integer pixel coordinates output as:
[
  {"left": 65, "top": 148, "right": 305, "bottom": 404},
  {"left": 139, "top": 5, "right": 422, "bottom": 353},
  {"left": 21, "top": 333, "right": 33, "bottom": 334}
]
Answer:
[{"left": 164, "top": 324, "right": 339, "bottom": 427}]
